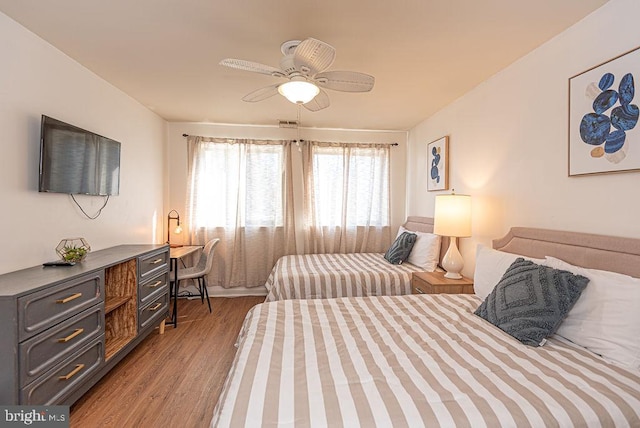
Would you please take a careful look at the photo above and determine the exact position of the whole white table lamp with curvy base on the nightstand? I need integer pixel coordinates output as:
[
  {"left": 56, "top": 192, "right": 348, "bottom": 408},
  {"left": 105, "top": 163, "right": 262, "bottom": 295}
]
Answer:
[{"left": 433, "top": 193, "right": 471, "bottom": 279}]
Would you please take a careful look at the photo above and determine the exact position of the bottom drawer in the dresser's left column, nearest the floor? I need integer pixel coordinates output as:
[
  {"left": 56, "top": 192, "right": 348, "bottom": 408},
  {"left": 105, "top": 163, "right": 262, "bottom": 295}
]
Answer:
[{"left": 20, "top": 336, "right": 104, "bottom": 405}]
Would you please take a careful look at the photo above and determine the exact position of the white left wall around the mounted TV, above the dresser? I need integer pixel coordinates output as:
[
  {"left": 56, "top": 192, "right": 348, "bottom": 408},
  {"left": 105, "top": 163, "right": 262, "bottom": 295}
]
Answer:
[{"left": 0, "top": 13, "right": 166, "bottom": 273}]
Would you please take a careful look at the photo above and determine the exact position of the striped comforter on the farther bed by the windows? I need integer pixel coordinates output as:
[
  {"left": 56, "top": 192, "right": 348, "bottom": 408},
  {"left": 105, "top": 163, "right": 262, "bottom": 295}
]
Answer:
[{"left": 265, "top": 253, "right": 422, "bottom": 302}]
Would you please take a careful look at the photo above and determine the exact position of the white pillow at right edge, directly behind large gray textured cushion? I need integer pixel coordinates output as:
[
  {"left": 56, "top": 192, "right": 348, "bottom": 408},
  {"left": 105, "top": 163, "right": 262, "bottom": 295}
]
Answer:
[{"left": 545, "top": 256, "right": 640, "bottom": 369}]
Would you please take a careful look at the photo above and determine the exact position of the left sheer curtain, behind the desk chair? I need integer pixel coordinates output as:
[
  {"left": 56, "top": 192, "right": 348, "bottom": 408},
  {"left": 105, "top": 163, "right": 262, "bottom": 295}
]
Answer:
[{"left": 187, "top": 136, "right": 296, "bottom": 288}]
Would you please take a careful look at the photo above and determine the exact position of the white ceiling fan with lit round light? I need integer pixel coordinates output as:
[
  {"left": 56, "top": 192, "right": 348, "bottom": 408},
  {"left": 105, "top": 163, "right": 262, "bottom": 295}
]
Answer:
[{"left": 220, "top": 38, "right": 375, "bottom": 111}]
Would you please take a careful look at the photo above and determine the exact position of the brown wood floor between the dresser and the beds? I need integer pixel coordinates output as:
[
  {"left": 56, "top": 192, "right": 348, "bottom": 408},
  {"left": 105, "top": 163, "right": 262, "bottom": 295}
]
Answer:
[{"left": 71, "top": 297, "right": 264, "bottom": 428}]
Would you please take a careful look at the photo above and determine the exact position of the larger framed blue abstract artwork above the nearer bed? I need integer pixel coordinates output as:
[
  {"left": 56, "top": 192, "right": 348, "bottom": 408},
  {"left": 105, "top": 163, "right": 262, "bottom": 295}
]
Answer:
[{"left": 569, "top": 48, "right": 640, "bottom": 176}]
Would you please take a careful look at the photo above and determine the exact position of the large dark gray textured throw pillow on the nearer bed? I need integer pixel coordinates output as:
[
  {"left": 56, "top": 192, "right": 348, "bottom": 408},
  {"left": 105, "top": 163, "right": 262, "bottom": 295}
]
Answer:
[{"left": 475, "top": 258, "right": 589, "bottom": 346}]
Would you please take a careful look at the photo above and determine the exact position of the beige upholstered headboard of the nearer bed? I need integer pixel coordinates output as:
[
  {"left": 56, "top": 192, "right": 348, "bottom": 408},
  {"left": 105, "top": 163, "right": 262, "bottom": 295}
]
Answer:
[{"left": 493, "top": 227, "right": 640, "bottom": 278}]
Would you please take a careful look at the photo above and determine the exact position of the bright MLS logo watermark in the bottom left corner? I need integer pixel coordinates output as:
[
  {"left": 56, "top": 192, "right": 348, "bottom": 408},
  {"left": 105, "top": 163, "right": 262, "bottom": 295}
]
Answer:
[{"left": 0, "top": 406, "right": 69, "bottom": 428}]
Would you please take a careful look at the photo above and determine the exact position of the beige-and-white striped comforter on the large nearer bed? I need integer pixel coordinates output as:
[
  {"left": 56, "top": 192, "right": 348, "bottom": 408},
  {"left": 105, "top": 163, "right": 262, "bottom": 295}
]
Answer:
[{"left": 211, "top": 294, "right": 640, "bottom": 427}]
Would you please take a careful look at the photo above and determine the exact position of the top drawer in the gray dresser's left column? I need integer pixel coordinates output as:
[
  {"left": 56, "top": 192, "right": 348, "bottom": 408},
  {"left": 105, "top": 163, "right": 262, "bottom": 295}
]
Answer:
[{"left": 18, "top": 271, "right": 104, "bottom": 341}]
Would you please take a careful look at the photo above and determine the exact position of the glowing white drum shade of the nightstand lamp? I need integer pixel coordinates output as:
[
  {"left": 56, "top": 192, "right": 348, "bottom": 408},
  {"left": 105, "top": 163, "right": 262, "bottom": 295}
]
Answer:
[{"left": 433, "top": 194, "right": 471, "bottom": 238}]
